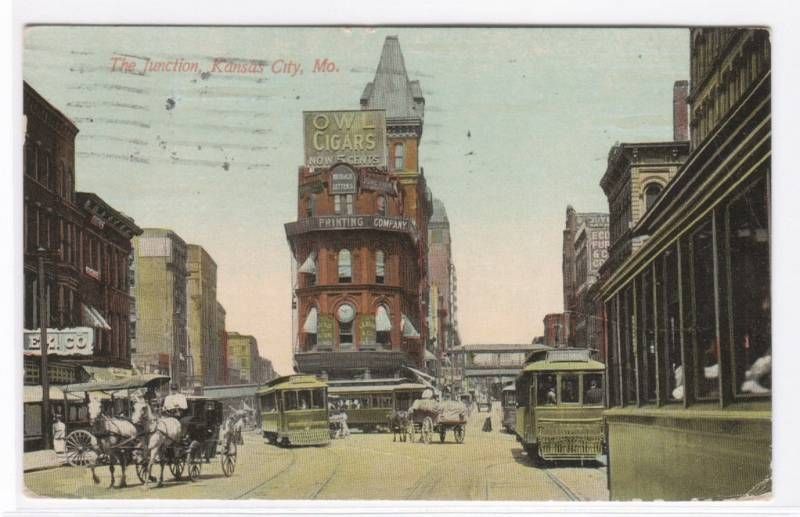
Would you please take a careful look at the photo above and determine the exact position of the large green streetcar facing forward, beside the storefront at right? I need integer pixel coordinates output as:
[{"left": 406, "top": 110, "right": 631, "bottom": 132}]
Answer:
[{"left": 515, "top": 348, "right": 605, "bottom": 462}]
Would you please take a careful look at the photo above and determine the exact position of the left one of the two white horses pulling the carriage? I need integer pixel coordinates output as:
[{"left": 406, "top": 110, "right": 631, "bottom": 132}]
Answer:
[{"left": 89, "top": 399, "right": 143, "bottom": 488}]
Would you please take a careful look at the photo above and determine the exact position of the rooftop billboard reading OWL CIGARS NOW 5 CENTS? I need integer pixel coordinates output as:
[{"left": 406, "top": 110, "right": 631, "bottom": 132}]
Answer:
[{"left": 303, "top": 110, "right": 386, "bottom": 167}]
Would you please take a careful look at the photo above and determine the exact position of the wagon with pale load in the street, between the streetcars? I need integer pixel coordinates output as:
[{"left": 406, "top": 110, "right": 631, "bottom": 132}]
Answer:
[{"left": 409, "top": 399, "right": 467, "bottom": 444}]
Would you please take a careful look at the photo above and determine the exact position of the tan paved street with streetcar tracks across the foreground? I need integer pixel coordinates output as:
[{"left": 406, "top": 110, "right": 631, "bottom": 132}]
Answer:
[{"left": 25, "top": 403, "right": 608, "bottom": 501}]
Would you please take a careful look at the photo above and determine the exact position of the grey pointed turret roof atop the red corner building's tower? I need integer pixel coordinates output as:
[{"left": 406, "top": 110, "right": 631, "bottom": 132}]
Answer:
[{"left": 361, "top": 36, "right": 425, "bottom": 120}]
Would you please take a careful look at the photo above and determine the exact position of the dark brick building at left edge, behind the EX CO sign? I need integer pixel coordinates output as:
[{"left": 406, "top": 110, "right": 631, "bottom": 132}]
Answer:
[{"left": 23, "top": 83, "right": 141, "bottom": 378}]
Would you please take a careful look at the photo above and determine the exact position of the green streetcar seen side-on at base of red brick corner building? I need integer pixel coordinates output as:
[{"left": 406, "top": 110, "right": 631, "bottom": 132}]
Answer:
[{"left": 328, "top": 379, "right": 425, "bottom": 432}]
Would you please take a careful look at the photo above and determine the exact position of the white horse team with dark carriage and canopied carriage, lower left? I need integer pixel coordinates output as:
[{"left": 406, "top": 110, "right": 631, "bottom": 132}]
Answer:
[{"left": 62, "top": 374, "right": 236, "bottom": 487}]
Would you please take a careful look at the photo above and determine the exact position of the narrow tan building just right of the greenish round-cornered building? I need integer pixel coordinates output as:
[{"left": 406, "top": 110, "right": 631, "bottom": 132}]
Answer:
[{"left": 186, "top": 244, "right": 223, "bottom": 386}]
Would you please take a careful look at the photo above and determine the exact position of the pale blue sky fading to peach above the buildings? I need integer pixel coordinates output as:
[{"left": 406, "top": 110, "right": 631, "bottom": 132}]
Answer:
[{"left": 23, "top": 27, "right": 689, "bottom": 373}]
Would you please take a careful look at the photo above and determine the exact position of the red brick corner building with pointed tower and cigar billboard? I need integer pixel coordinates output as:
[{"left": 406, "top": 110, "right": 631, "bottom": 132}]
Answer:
[{"left": 285, "top": 36, "right": 432, "bottom": 379}]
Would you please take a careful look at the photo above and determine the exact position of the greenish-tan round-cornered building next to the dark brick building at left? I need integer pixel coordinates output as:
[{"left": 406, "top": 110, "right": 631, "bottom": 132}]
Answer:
[{"left": 133, "top": 228, "right": 191, "bottom": 387}]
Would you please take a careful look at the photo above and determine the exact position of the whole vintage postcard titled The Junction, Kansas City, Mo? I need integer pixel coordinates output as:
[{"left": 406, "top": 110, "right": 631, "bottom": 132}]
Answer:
[{"left": 16, "top": 24, "right": 773, "bottom": 502}]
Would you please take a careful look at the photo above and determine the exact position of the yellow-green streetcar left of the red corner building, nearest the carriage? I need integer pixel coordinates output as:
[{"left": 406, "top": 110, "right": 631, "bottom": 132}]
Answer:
[{"left": 256, "top": 375, "right": 331, "bottom": 446}]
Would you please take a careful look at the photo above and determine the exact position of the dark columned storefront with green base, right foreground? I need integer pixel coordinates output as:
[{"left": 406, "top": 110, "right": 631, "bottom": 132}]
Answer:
[{"left": 601, "top": 73, "right": 772, "bottom": 500}]
